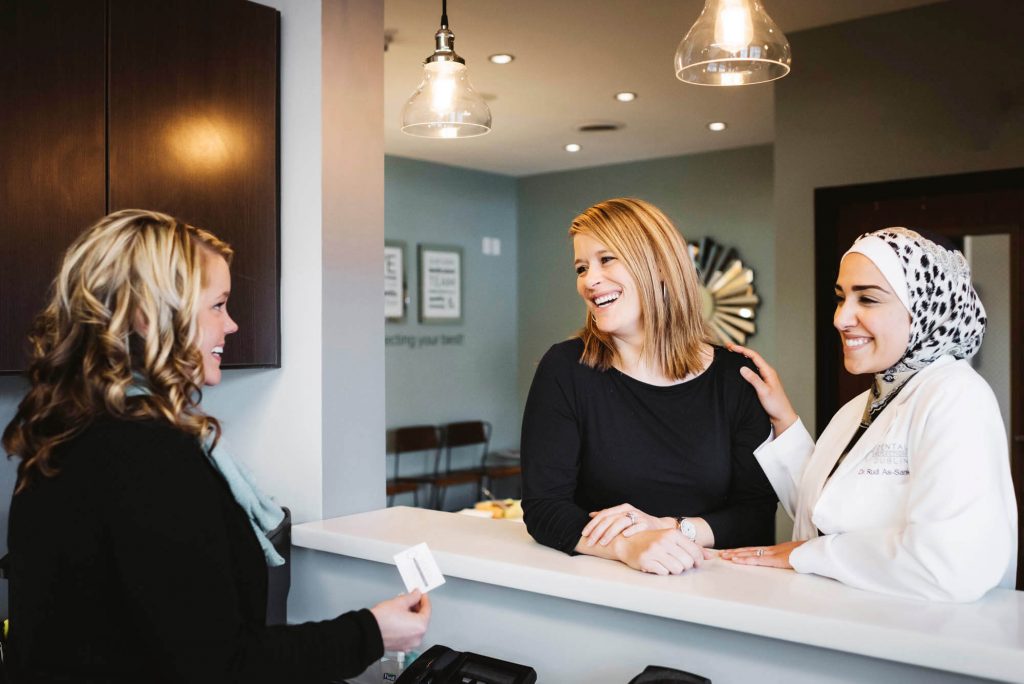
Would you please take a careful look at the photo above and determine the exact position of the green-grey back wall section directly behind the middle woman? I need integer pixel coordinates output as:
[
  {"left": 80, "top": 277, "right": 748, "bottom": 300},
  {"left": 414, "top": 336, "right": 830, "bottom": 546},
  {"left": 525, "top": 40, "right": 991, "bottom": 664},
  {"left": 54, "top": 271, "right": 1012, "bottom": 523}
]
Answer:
[{"left": 518, "top": 145, "right": 775, "bottom": 408}]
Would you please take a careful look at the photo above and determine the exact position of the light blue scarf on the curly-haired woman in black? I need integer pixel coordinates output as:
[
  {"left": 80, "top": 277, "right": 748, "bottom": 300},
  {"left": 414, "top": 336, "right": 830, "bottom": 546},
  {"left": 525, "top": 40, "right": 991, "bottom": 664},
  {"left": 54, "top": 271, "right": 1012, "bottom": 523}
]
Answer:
[{"left": 125, "top": 378, "right": 285, "bottom": 567}]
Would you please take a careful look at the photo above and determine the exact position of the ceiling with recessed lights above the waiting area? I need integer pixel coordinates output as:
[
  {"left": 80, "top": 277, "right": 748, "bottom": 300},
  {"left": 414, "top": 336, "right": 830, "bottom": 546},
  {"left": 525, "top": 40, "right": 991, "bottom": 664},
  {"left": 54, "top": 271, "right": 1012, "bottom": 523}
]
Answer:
[{"left": 384, "top": 0, "right": 937, "bottom": 176}]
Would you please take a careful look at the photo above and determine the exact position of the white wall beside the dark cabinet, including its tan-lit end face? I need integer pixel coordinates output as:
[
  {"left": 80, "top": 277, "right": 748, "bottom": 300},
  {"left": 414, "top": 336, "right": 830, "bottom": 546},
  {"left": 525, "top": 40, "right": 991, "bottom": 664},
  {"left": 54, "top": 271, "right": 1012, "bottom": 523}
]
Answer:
[{"left": 204, "top": 0, "right": 384, "bottom": 522}]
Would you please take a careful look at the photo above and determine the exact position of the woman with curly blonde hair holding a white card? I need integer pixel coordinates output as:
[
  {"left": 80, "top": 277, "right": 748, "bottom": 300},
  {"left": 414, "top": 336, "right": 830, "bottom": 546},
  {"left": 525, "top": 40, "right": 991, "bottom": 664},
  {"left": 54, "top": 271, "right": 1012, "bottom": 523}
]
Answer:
[{"left": 3, "top": 210, "right": 430, "bottom": 682}]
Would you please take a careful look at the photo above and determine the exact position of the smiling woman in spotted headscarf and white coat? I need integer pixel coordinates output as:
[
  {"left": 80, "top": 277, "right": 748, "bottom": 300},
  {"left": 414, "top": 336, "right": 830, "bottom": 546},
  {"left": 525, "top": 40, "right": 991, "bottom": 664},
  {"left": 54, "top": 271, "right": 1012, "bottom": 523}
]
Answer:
[{"left": 722, "top": 228, "right": 1017, "bottom": 601}]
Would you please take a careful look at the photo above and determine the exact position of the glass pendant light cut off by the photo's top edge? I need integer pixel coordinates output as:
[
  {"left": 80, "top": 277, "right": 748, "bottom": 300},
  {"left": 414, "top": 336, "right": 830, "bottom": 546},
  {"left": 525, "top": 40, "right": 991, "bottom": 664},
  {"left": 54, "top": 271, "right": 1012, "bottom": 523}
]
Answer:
[{"left": 676, "top": 0, "right": 793, "bottom": 86}]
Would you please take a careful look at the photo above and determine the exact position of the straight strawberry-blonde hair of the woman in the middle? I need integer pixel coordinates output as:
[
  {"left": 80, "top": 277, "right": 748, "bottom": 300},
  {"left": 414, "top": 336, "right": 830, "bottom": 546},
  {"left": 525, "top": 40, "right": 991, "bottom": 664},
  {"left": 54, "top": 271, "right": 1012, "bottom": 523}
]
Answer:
[{"left": 569, "top": 198, "right": 711, "bottom": 380}]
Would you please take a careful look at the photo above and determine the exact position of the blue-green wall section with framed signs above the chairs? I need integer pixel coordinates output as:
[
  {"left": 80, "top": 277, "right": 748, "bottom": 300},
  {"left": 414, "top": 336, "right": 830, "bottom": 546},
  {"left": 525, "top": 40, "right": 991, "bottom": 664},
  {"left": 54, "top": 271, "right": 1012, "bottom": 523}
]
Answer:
[{"left": 384, "top": 157, "right": 519, "bottom": 472}]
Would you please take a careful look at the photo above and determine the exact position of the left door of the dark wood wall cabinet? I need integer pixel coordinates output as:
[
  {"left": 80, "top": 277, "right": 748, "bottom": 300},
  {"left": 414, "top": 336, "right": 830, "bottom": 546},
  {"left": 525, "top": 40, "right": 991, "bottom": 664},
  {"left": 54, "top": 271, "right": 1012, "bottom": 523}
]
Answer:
[{"left": 0, "top": 0, "right": 106, "bottom": 372}]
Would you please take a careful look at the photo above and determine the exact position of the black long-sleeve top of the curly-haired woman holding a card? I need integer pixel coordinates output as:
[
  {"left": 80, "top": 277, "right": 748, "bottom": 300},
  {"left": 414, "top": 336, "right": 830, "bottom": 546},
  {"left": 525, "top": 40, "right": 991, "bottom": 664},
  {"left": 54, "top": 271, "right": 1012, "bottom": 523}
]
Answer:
[{"left": 8, "top": 419, "right": 383, "bottom": 682}]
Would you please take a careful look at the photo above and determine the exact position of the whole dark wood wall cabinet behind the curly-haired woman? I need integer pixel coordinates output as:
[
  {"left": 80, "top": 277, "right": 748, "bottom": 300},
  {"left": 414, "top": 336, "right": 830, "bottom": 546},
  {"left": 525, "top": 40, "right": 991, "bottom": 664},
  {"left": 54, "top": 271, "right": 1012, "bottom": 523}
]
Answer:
[{"left": 0, "top": 0, "right": 281, "bottom": 373}]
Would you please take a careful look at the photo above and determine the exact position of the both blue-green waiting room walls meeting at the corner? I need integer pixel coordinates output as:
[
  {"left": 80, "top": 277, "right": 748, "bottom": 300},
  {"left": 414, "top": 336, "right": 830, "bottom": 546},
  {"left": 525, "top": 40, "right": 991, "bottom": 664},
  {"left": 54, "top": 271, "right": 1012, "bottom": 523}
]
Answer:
[{"left": 384, "top": 152, "right": 774, "bottom": 507}]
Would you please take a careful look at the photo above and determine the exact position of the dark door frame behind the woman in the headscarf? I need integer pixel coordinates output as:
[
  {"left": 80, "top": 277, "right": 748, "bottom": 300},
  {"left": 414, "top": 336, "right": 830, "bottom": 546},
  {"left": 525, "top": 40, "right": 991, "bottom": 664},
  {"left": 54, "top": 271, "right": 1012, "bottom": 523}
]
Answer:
[{"left": 814, "top": 168, "right": 1024, "bottom": 589}]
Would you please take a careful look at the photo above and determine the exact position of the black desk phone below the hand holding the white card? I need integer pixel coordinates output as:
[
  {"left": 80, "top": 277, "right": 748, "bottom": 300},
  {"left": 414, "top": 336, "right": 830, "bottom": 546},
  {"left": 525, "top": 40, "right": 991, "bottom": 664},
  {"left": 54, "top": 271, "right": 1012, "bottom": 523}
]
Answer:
[{"left": 395, "top": 645, "right": 537, "bottom": 684}]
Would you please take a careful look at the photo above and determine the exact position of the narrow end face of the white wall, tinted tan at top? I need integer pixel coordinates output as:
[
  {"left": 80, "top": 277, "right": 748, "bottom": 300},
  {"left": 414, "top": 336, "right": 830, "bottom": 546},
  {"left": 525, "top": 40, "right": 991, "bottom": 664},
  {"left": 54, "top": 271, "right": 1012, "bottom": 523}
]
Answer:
[{"left": 319, "top": 0, "right": 385, "bottom": 518}]
